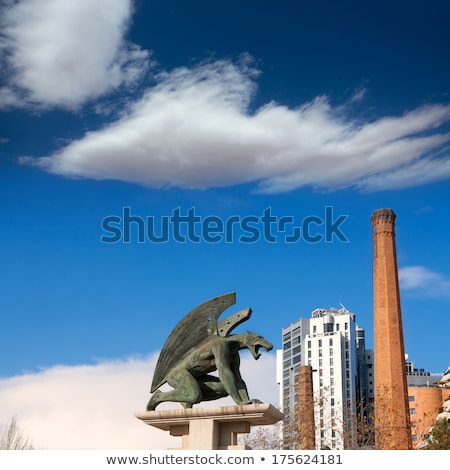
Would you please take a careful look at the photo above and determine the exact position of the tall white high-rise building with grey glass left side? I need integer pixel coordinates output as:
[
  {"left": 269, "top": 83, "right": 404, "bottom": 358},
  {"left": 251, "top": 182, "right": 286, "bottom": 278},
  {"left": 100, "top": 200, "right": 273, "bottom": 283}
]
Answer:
[{"left": 278, "top": 307, "right": 371, "bottom": 449}]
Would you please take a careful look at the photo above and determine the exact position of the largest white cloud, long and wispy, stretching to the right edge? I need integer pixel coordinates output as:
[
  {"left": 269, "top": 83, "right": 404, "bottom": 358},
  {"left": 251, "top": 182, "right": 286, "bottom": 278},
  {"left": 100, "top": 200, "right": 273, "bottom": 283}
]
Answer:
[{"left": 22, "top": 57, "right": 450, "bottom": 193}]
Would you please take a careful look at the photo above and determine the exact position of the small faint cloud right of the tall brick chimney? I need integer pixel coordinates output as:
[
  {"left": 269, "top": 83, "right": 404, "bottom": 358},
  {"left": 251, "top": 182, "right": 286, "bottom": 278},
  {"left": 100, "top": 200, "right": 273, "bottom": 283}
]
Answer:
[{"left": 398, "top": 266, "right": 450, "bottom": 297}]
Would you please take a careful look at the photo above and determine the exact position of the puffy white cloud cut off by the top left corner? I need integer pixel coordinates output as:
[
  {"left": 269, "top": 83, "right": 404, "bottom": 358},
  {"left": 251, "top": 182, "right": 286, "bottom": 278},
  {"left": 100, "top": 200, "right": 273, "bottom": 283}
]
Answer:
[{"left": 0, "top": 0, "right": 149, "bottom": 108}]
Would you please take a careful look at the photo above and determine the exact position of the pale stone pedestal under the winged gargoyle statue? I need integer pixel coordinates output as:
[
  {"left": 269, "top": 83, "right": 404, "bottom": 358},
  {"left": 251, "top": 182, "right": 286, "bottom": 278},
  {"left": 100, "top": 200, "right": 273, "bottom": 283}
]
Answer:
[{"left": 135, "top": 403, "right": 283, "bottom": 450}]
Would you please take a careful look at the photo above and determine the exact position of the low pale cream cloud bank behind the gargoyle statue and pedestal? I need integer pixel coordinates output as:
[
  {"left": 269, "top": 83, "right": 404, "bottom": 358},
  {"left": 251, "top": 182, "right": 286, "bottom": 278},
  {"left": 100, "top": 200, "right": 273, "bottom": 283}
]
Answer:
[{"left": 0, "top": 354, "right": 278, "bottom": 449}]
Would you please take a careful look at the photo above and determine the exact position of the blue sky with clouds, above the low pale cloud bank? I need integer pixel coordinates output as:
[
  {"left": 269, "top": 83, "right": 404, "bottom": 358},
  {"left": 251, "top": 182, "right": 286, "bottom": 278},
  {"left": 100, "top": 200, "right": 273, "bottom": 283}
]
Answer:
[{"left": 0, "top": 0, "right": 450, "bottom": 426}]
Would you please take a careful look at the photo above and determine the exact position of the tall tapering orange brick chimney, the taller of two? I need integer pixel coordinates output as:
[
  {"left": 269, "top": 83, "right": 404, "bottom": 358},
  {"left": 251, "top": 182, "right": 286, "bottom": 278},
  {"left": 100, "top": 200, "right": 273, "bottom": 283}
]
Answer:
[{"left": 371, "top": 209, "right": 411, "bottom": 450}]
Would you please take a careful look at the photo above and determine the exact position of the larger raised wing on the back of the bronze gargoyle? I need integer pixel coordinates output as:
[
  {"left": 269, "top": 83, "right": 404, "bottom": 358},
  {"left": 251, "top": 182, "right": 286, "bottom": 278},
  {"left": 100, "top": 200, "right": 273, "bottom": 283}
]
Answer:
[{"left": 150, "top": 292, "right": 237, "bottom": 393}]
